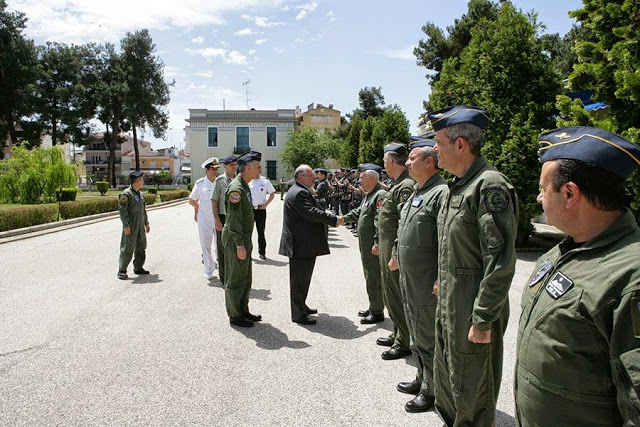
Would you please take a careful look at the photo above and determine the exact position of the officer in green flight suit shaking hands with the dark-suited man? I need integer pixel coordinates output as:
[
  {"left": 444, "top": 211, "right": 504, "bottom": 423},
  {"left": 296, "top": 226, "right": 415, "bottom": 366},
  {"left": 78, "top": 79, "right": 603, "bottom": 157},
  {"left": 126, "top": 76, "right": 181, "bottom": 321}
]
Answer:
[{"left": 344, "top": 163, "right": 386, "bottom": 324}]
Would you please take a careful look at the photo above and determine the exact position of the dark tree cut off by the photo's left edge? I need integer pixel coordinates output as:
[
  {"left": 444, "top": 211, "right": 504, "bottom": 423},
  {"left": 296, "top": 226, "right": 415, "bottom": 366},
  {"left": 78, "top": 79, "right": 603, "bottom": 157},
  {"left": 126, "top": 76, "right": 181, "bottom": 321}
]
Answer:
[{"left": 0, "top": 0, "right": 37, "bottom": 144}]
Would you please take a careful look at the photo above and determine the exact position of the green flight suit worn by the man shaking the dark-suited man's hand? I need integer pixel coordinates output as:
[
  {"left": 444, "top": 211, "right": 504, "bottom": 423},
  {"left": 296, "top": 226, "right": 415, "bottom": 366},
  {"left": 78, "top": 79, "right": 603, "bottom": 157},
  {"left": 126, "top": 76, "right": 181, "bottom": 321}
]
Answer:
[{"left": 344, "top": 184, "right": 386, "bottom": 314}]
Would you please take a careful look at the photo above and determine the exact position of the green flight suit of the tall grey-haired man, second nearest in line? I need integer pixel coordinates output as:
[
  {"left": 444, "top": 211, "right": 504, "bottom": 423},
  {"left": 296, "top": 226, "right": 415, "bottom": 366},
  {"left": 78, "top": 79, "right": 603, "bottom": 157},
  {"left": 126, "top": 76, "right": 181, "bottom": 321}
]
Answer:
[{"left": 434, "top": 156, "right": 518, "bottom": 426}]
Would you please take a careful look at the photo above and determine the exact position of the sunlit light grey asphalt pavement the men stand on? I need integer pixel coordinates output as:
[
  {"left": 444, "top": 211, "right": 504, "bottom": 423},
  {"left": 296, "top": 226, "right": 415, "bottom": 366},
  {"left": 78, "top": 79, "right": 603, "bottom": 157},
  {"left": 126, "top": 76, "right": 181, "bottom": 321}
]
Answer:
[{"left": 0, "top": 197, "right": 539, "bottom": 426}]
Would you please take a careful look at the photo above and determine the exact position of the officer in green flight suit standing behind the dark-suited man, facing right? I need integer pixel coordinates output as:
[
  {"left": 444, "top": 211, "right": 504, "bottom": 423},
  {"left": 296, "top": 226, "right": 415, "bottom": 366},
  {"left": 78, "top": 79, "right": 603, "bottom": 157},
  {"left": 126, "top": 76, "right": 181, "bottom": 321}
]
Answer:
[{"left": 222, "top": 151, "right": 262, "bottom": 327}]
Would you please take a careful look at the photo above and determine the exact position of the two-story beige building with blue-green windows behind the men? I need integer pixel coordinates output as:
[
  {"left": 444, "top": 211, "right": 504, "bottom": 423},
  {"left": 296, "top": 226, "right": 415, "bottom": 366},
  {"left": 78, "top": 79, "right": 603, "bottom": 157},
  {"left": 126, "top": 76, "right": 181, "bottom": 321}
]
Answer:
[{"left": 185, "top": 109, "right": 298, "bottom": 182}]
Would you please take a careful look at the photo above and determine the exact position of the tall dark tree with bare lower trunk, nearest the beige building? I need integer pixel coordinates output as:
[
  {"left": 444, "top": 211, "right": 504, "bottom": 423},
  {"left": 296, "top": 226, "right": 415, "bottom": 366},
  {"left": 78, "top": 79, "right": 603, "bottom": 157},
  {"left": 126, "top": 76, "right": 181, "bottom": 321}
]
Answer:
[{"left": 121, "top": 30, "right": 175, "bottom": 170}]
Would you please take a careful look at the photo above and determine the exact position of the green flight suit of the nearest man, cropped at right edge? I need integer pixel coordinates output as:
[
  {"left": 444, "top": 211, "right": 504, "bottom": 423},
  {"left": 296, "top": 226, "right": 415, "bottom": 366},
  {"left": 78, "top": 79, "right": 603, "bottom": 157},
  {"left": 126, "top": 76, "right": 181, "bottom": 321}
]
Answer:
[{"left": 514, "top": 210, "right": 640, "bottom": 427}]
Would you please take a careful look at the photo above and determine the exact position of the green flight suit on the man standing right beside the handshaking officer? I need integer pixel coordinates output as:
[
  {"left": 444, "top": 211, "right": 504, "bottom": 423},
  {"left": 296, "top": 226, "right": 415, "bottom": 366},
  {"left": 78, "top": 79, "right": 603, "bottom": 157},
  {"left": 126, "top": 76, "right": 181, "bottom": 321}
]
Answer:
[{"left": 378, "top": 169, "right": 416, "bottom": 350}]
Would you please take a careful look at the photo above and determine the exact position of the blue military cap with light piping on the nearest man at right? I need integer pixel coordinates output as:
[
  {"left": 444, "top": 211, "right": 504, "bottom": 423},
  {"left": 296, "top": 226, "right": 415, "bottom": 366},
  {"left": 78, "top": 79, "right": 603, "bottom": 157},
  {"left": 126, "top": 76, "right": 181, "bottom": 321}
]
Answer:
[{"left": 538, "top": 126, "right": 640, "bottom": 178}]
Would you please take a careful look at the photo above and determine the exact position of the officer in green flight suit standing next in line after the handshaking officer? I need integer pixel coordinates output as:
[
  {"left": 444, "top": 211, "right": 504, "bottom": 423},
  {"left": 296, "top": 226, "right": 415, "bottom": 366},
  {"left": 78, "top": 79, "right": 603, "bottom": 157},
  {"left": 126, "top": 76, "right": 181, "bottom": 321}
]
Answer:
[{"left": 374, "top": 142, "right": 416, "bottom": 360}]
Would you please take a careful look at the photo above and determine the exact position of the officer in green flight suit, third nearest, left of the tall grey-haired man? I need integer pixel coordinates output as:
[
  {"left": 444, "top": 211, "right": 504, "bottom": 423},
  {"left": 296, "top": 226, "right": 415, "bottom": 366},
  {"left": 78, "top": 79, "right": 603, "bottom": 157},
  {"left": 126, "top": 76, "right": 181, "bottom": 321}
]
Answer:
[{"left": 389, "top": 139, "right": 447, "bottom": 412}]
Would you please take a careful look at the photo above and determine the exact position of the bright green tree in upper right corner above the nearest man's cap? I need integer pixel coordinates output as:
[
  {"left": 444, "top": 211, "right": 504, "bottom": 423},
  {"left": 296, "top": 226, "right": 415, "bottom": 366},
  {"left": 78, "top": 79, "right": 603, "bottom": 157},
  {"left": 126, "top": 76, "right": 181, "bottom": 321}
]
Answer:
[{"left": 558, "top": 0, "right": 640, "bottom": 222}]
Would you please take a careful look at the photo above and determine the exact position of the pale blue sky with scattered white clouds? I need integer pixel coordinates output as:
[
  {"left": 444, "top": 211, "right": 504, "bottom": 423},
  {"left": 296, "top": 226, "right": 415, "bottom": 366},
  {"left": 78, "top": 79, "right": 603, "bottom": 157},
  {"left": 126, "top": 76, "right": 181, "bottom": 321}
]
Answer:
[{"left": 7, "top": 0, "right": 582, "bottom": 149}]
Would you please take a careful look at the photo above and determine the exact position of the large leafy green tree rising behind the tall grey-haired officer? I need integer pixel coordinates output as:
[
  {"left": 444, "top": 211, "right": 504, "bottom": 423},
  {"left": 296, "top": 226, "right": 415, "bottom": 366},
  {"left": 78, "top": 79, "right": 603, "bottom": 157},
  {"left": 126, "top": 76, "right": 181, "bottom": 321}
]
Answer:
[{"left": 422, "top": 2, "right": 562, "bottom": 243}]
